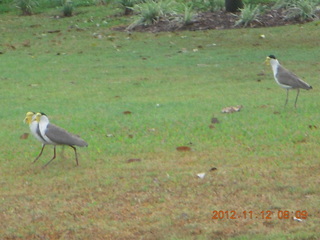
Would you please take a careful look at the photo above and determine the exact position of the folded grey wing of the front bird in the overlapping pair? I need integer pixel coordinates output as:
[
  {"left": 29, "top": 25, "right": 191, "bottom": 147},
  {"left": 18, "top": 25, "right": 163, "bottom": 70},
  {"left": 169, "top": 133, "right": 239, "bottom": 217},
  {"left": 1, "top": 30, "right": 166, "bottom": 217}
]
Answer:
[{"left": 46, "top": 123, "right": 88, "bottom": 147}]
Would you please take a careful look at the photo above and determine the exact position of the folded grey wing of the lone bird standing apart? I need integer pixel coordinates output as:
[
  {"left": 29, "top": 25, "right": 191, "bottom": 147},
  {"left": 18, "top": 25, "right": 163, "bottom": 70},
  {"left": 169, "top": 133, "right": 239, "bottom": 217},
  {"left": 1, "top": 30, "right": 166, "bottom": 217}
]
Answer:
[{"left": 277, "top": 66, "right": 312, "bottom": 90}]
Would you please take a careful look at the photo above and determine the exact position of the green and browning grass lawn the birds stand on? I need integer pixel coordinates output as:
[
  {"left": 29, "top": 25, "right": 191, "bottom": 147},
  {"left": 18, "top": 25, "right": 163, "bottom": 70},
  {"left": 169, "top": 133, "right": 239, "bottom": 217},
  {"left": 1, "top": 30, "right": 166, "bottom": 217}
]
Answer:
[{"left": 0, "top": 7, "right": 320, "bottom": 240}]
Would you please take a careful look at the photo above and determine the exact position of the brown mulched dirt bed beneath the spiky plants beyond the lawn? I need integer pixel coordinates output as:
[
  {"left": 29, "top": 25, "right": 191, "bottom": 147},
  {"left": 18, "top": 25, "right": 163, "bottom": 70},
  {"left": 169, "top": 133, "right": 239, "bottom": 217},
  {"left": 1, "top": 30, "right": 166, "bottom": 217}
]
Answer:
[{"left": 114, "top": 9, "right": 320, "bottom": 32}]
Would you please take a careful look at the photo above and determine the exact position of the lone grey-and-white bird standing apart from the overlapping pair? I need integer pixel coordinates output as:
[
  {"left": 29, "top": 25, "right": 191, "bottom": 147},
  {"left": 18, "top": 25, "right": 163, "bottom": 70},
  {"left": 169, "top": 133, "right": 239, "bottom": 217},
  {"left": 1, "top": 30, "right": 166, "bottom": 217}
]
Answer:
[{"left": 266, "top": 55, "right": 312, "bottom": 108}]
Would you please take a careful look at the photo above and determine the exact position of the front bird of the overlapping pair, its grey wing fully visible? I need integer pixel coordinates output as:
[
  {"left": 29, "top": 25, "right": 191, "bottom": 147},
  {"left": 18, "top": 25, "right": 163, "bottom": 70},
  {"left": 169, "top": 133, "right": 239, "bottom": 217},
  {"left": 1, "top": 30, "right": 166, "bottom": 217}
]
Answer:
[{"left": 35, "top": 113, "right": 88, "bottom": 167}]
